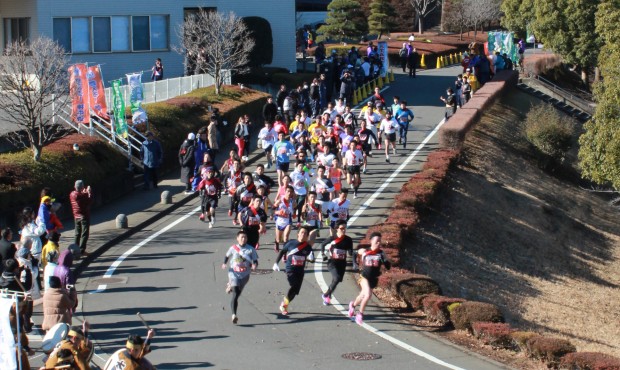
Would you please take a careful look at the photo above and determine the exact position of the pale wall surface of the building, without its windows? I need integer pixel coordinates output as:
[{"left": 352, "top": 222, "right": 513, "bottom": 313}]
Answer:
[{"left": 0, "top": 0, "right": 296, "bottom": 81}]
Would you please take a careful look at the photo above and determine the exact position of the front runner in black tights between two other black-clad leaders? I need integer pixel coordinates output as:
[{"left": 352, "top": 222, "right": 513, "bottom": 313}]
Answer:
[{"left": 321, "top": 220, "right": 353, "bottom": 306}]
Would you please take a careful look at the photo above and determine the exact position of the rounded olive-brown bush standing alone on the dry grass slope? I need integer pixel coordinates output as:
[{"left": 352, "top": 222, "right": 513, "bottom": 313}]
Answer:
[{"left": 525, "top": 104, "right": 575, "bottom": 163}]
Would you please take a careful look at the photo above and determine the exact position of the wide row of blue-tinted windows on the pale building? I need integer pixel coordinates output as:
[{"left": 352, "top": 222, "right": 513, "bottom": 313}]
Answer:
[{"left": 53, "top": 15, "right": 169, "bottom": 53}]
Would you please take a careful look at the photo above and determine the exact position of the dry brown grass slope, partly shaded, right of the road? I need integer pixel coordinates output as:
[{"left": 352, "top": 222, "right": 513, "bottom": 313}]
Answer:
[{"left": 402, "top": 91, "right": 620, "bottom": 356}]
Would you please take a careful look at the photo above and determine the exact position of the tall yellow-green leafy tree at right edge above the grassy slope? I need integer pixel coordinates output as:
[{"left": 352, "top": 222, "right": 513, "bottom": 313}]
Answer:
[{"left": 579, "top": 0, "right": 620, "bottom": 191}]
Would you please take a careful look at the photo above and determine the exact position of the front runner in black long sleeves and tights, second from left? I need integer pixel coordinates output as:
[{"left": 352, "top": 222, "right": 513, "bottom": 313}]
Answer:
[{"left": 273, "top": 225, "right": 314, "bottom": 316}]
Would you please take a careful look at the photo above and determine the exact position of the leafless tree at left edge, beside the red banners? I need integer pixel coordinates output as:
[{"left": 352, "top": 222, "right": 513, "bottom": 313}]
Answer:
[{"left": 0, "top": 37, "right": 69, "bottom": 162}]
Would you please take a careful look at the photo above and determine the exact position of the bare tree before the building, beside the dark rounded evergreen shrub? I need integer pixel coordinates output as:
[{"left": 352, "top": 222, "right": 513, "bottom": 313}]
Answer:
[{"left": 176, "top": 9, "right": 254, "bottom": 95}]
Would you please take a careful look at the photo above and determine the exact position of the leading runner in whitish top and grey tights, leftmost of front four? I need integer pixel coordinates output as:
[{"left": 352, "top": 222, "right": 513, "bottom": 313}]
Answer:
[{"left": 222, "top": 231, "right": 258, "bottom": 324}]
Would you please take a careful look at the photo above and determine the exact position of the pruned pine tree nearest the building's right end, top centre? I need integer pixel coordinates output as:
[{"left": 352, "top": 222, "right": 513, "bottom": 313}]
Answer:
[{"left": 318, "top": 0, "right": 367, "bottom": 41}]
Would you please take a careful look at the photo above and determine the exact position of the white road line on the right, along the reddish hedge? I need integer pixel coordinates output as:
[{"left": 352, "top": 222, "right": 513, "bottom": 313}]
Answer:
[{"left": 314, "top": 119, "right": 464, "bottom": 370}]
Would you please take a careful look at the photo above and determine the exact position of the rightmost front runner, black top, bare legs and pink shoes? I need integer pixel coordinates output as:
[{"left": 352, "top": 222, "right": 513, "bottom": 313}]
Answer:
[{"left": 349, "top": 233, "right": 391, "bottom": 325}]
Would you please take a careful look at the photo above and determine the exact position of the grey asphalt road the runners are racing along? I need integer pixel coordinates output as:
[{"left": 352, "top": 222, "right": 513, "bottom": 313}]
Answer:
[{"left": 80, "top": 68, "right": 504, "bottom": 369}]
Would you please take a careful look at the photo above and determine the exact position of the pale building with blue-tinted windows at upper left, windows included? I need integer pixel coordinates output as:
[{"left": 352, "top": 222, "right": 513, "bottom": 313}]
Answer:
[{"left": 0, "top": 0, "right": 296, "bottom": 80}]
